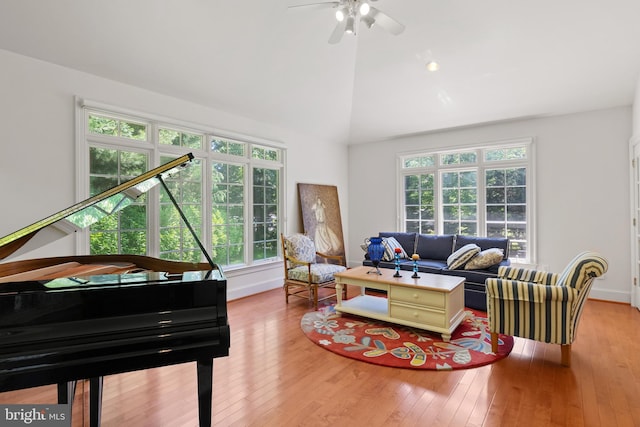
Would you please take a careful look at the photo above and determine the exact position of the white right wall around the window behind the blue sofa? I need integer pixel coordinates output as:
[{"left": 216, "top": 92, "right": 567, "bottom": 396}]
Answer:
[{"left": 348, "top": 107, "right": 632, "bottom": 302}]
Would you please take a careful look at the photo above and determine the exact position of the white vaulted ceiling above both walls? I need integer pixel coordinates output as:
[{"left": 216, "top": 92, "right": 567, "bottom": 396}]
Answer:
[{"left": 0, "top": 0, "right": 640, "bottom": 143}]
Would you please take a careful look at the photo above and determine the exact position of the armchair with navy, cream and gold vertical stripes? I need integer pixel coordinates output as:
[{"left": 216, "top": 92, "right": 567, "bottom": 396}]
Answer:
[{"left": 486, "top": 252, "right": 608, "bottom": 366}]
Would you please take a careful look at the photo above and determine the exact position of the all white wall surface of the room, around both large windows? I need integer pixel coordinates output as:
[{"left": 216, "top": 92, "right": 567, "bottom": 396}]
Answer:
[{"left": 0, "top": 46, "right": 640, "bottom": 302}]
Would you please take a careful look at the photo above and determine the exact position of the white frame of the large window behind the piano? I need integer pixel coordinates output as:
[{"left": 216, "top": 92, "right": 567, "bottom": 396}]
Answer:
[{"left": 75, "top": 97, "right": 286, "bottom": 271}]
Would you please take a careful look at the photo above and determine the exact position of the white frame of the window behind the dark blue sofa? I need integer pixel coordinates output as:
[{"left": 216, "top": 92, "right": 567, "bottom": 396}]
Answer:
[{"left": 396, "top": 137, "right": 538, "bottom": 266}]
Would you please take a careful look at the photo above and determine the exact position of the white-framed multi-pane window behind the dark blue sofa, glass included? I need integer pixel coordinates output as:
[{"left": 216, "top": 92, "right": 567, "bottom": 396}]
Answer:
[{"left": 399, "top": 139, "right": 534, "bottom": 262}]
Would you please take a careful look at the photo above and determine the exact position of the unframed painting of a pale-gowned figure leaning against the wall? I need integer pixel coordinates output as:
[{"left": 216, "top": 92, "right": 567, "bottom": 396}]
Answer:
[{"left": 298, "top": 184, "right": 345, "bottom": 255}]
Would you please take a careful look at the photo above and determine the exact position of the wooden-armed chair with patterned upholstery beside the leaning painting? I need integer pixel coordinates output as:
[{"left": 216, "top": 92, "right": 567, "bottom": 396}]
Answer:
[{"left": 280, "top": 233, "right": 347, "bottom": 309}]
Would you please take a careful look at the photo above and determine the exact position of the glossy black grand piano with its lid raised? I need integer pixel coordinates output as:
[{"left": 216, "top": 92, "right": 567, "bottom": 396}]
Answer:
[{"left": 0, "top": 154, "right": 230, "bottom": 426}]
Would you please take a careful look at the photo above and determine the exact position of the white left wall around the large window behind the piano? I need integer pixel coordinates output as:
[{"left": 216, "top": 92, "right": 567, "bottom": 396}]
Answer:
[{"left": 0, "top": 50, "right": 348, "bottom": 299}]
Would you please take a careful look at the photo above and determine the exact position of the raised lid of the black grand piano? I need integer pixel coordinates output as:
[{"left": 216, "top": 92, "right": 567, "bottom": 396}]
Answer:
[{"left": 0, "top": 153, "right": 195, "bottom": 260}]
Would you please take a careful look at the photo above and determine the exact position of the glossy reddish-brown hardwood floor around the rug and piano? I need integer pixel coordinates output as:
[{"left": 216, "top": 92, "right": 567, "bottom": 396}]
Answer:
[{"left": 0, "top": 289, "right": 640, "bottom": 427}]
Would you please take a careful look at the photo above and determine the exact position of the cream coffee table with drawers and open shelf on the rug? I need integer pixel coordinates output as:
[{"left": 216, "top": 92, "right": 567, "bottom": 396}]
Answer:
[{"left": 334, "top": 266, "right": 464, "bottom": 341}]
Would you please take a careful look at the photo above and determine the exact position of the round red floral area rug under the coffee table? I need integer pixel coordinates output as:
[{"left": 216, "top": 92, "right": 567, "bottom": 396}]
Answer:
[{"left": 300, "top": 306, "right": 513, "bottom": 370}]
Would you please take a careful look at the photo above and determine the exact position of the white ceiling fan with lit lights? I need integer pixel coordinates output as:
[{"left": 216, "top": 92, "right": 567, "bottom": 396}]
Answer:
[{"left": 289, "top": 0, "right": 404, "bottom": 44}]
